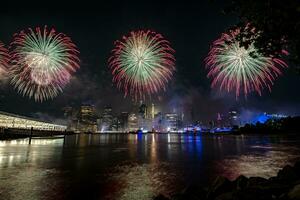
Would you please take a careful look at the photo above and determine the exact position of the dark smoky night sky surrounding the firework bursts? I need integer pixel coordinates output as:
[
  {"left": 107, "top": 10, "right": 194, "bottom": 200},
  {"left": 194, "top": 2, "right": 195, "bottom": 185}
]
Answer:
[{"left": 0, "top": 0, "right": 300, "bottom": 120}]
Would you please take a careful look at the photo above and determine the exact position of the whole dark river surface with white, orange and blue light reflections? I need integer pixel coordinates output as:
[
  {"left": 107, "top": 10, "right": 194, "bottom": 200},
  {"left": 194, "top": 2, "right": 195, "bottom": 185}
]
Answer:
[{"left": 0, "top": 134, "right": 300, "bottom": 200}]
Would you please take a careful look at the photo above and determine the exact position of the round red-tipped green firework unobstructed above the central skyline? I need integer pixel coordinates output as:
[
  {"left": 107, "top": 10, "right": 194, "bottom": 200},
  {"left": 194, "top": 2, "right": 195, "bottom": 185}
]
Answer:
[{"left": 109, "top": 31, "right": 175, "bottom": 99}]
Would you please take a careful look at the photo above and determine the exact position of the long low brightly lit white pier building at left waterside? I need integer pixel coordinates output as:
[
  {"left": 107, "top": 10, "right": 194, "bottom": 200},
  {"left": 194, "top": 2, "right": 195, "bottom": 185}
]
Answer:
[{"left": 0, "top": 111, "right": 67, "bottom": 131}]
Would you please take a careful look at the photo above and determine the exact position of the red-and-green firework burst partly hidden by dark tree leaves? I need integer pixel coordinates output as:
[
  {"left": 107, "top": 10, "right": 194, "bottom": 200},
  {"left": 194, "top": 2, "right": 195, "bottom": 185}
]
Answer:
[{"left": 205, "top": 29, "right": 287, "bottom": 97}]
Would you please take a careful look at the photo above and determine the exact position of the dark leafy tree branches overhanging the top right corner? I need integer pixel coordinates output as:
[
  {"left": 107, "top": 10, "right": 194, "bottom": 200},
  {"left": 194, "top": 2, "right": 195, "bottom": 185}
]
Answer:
[{"left": 224, "top": 0, "right": 300, "bottom": 73}]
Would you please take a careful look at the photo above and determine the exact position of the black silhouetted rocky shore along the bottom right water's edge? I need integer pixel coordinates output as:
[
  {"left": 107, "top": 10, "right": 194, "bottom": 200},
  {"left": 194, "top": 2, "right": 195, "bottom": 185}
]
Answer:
[{"left": 153, "top": 161, "right": 300, "bottom": 200}]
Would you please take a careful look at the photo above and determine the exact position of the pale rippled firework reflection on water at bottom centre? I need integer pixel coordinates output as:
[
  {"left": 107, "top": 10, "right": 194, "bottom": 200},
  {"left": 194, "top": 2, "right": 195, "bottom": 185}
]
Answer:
[{"left": 105, "top": 163, "right": 183, "bottom": 200}]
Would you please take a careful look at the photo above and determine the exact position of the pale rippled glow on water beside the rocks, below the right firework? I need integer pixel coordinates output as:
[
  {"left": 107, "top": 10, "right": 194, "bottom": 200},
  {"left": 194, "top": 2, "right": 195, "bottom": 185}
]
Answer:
[{"left": 216, "top": 145, "right": 300, "bottom": 179}]
